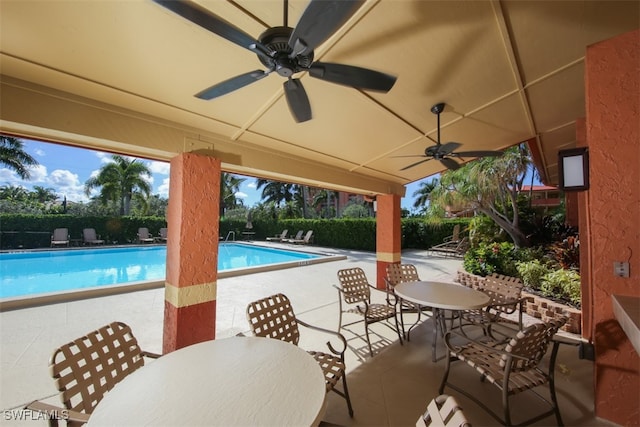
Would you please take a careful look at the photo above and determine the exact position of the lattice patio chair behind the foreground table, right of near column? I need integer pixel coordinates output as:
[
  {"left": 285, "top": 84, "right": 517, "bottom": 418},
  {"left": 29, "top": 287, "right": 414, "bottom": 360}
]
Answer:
[{"left": 247, "top": 294, "right": 353, "bottom": 417}]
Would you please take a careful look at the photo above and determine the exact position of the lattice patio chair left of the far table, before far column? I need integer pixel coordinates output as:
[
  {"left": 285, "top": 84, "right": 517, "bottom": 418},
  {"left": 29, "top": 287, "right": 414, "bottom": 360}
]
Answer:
[{"left": 334, "top": 267, "right": 402, "bottom": 357}]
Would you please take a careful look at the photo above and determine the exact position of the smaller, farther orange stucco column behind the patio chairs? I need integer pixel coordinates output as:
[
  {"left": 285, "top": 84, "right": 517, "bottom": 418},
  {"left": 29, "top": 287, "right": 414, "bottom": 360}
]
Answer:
[{"left": 376, "top": 194, "right": 402, "bottom": 289}]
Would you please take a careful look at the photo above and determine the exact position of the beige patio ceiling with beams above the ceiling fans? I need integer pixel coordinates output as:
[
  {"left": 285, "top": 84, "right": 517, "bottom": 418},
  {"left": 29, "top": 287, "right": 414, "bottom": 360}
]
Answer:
[{"left": 0, "top": 0, "right": 640, "bottom": 194}]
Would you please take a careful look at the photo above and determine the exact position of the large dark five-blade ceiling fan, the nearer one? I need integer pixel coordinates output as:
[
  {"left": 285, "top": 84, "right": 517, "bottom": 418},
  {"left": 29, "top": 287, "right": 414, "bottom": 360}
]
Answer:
[{"left": 153, "top": 0, "right": 396, "bottom": 123}]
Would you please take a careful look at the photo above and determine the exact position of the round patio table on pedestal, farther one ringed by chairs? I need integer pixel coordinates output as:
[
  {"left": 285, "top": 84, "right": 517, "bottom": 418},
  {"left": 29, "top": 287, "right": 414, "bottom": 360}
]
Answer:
[{"left": 394, "top": 281, "right": 489, "bottom": 362}]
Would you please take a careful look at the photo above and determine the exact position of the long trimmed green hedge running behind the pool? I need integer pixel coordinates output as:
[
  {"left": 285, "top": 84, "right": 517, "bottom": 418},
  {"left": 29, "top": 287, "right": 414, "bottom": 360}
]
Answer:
[{"left": 0, "top": 214, "right": 469, "bottom": 252}]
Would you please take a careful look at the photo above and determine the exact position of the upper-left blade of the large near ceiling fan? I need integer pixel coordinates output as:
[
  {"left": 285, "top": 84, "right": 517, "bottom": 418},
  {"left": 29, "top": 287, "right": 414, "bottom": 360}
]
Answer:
[{"left": 153, "top": 0, "right": 268, "bottom": 56}]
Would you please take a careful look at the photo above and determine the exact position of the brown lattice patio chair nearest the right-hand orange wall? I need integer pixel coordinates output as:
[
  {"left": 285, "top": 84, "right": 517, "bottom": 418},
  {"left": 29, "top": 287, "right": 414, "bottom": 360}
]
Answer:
[{"left": 439, "top": 317, "right": 567, "bottom": 426}]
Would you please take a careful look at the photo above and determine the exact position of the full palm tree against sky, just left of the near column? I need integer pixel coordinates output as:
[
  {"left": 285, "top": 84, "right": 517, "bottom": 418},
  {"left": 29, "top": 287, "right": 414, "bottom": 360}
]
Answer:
[{"left": 84, "top": 154, "right": 151, "bottom": 215}]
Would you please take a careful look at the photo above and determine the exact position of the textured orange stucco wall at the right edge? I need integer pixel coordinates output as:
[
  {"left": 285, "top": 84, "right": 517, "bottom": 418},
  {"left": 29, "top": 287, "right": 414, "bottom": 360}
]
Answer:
[{"left": 581, "top": 30, "right": 640, "bottom": 425}]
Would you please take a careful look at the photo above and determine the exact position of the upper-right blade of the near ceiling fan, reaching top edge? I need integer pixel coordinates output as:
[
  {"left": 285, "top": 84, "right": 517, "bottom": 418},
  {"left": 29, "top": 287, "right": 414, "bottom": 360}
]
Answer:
[{"left": 289, "top": 0, "right": 364, "bottom": 58}]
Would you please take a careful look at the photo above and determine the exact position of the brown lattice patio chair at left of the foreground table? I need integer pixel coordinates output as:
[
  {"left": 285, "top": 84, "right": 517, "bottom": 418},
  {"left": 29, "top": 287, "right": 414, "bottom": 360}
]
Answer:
[{"left": 26, "top": 322, "right": 160, "bottom": 426}]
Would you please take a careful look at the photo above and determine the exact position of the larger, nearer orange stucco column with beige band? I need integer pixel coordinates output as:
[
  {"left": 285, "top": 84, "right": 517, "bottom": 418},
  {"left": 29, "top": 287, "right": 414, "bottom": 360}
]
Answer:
[{"left": 162, "top": 153, "right": 220, "bottom": 353}]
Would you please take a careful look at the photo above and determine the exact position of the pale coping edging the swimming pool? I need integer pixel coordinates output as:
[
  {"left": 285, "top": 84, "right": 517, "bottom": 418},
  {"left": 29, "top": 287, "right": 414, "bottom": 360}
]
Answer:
[{"left": 0, "top": 246, "right": 347, "bottom": 313}]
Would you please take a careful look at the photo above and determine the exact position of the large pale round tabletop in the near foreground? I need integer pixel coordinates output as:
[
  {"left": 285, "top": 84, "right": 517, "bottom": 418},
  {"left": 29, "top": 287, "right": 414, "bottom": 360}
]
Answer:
[{"left": 88, "top": 337, "right": 326, "bottom": 426}]
